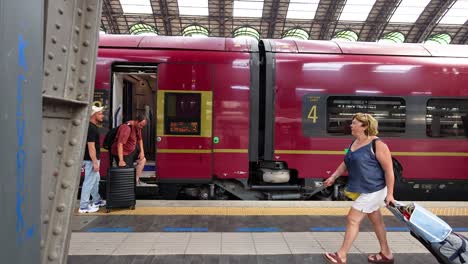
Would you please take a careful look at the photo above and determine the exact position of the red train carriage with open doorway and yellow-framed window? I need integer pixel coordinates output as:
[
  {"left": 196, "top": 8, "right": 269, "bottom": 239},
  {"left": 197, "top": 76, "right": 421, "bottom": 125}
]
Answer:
[{"left": 95, "top": 36, "right": 259, "bottom": 200}]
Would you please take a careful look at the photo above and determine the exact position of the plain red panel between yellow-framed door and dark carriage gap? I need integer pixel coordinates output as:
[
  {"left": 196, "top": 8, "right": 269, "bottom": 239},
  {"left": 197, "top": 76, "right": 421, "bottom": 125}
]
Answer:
[{"left": 213, "top": 62, "right": 251, "bottom": 179}]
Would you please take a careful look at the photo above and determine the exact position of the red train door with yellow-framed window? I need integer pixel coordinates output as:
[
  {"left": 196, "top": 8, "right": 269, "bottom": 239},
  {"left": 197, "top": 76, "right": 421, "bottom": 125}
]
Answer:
[{"left": 156, "top": 63, "right": 213, "bottom": 183}]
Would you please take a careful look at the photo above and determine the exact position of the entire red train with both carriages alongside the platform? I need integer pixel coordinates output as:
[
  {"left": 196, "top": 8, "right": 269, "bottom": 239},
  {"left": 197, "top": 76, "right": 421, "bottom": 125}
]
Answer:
[{"left": 95, "top": 36, "right": 468, "bottom": 199}]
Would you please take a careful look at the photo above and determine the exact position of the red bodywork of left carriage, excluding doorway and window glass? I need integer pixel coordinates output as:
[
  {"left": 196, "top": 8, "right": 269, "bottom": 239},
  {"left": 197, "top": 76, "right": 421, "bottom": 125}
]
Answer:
[{"left": 96, "top": 36, "right": 252, "bottom": 184}]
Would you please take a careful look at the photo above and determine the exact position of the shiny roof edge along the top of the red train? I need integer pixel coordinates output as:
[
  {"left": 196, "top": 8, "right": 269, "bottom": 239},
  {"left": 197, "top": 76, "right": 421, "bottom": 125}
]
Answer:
[{"left": 99, "top": 34, "right": 468, "bottom": 58}]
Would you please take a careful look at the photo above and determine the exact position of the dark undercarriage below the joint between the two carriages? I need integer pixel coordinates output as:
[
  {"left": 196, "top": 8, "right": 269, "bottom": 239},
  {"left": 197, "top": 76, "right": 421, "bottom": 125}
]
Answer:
[{"left": 154, "top": 161, "right": 347, "bottom": 201}]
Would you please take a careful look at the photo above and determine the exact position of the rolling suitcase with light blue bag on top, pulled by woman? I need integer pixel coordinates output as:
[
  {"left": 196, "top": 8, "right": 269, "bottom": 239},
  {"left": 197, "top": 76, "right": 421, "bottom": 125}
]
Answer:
[{"left": 388, "top": 202, "right": 468, "bottom": 264}]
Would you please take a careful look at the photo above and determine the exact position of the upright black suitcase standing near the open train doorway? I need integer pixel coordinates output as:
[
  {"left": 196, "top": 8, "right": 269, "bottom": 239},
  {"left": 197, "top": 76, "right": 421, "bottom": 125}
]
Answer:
[{"left": 106, "top": 167, "right": 136, "bottom": 213}]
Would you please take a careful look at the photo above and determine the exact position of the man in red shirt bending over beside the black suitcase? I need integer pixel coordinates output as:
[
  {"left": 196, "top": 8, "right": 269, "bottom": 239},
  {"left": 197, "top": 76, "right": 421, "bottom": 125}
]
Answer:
[{"left": 111, "top": 115, "right": 147, "bottom": 185}]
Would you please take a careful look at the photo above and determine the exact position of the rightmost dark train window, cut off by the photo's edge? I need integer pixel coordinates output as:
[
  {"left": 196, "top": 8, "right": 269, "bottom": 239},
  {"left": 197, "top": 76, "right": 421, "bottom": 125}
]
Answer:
[{"left": 426, "top": 99, "right": 468, "bottom": 137}]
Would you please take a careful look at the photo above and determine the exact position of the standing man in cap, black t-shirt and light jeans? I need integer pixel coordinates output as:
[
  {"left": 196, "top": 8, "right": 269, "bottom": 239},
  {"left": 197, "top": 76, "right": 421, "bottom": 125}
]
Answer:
[{"left": 78, "top": 105, "right": 106, "bottom": 213}]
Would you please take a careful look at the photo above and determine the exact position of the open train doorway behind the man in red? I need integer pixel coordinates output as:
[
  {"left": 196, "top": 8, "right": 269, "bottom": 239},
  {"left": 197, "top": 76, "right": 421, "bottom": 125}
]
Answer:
[{"left": 109, "top": 64, "right": 158, "bottom": 184}]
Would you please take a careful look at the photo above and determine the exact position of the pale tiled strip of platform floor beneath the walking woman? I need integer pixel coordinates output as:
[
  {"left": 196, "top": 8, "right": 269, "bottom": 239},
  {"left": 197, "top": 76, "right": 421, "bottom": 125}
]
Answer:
[{"left": 69, "top": 232, "right": 467, "bottom": 255}]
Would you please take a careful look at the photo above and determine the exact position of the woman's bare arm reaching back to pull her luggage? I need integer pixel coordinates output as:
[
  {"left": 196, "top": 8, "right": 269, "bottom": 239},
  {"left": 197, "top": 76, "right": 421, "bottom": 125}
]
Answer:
[{"left": 375, "top": 140, "right": 395, "bottom": 205}]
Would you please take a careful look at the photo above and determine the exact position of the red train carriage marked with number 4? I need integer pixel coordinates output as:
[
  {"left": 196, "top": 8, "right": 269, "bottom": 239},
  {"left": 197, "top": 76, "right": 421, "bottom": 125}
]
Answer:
[{"left": 261, "top": 40, "right": 468, "bottom": 200}]
